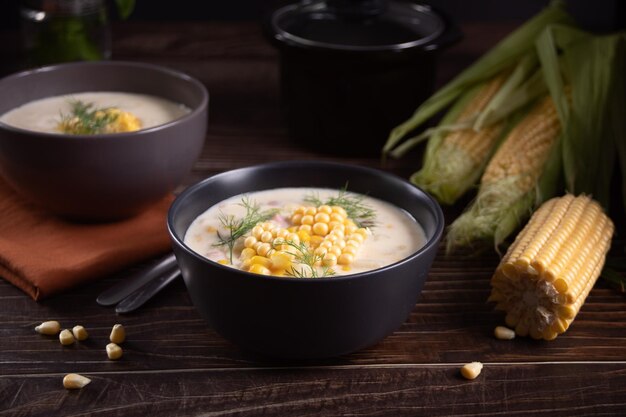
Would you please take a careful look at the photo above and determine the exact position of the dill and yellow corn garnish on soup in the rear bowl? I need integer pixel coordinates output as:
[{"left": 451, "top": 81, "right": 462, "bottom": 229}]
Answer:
[{"left": 59, "top": 100, "right": 119, "bottom": 135}]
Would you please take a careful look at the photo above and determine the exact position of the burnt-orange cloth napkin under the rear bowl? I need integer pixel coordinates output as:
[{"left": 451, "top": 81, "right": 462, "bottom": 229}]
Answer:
[{"left": 0, "top": 180, "right": 174, "bottom": 300}]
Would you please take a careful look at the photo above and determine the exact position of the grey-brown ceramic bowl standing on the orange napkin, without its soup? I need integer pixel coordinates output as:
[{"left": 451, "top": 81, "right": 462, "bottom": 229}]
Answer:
[{"left": 0, "top": 61, "right": 208, "bottom": 220}]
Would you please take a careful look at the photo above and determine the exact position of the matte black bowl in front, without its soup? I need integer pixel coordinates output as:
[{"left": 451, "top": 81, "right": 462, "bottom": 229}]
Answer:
[{"left": 168, "top": 161, "right": 444, "bottom": 359}]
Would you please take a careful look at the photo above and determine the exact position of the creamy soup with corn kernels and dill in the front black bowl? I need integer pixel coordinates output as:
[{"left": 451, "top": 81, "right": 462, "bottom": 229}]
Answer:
[{"left": 184, "top": 188, "right": 426, "bottom": 277}]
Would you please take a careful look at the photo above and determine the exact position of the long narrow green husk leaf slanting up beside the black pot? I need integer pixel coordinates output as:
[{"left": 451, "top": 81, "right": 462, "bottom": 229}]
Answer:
[{"left": 382, "top": 1, "right": 572, "bottom": 156}]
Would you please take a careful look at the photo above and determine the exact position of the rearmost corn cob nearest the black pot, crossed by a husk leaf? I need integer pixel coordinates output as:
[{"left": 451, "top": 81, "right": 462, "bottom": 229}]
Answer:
[{"left": 411, "top": 71, "right": 509, "bottom": 204}]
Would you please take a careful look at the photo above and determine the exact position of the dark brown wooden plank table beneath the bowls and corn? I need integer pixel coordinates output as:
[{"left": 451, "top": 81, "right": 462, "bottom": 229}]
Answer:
[{"left": 0, "top": 22, "right": 626, "bottom": 417}]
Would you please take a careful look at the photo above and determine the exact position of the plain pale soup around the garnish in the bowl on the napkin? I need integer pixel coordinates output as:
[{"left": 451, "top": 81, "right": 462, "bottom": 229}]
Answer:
[{"left": 0, "top": 91, "right": 190, "bottom": 133}]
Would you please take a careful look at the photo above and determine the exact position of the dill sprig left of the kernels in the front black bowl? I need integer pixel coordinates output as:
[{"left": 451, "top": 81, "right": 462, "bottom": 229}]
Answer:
[{"left": 215, "top": 196, "right": 278, "bottom": 264}]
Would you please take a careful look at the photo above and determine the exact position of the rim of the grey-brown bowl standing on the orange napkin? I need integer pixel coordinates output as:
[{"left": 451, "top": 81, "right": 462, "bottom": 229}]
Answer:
[{"left": 0, "top": 60, "right": 209, "bottom": 141}]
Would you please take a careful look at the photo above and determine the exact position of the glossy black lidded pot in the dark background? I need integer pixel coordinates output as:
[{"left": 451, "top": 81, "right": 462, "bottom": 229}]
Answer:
[{"left": 265, "top": 0, "right": 461, "bottom": 155}]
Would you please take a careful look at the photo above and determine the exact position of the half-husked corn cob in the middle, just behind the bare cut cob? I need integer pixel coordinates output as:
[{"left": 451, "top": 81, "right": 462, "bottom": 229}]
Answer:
[{"left": 447, "top": 96, "right": 561, "bottom": 252}]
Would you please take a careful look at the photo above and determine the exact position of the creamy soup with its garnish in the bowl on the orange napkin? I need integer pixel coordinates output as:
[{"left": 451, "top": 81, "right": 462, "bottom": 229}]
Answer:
[{"left": 0, "top": 92, "right": 190, "bottom": 134}]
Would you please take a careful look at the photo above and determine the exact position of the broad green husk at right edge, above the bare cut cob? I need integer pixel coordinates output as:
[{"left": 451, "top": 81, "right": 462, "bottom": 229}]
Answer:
[{"left": 537, "top": 25, "right": 626, "bottom": 209}]
